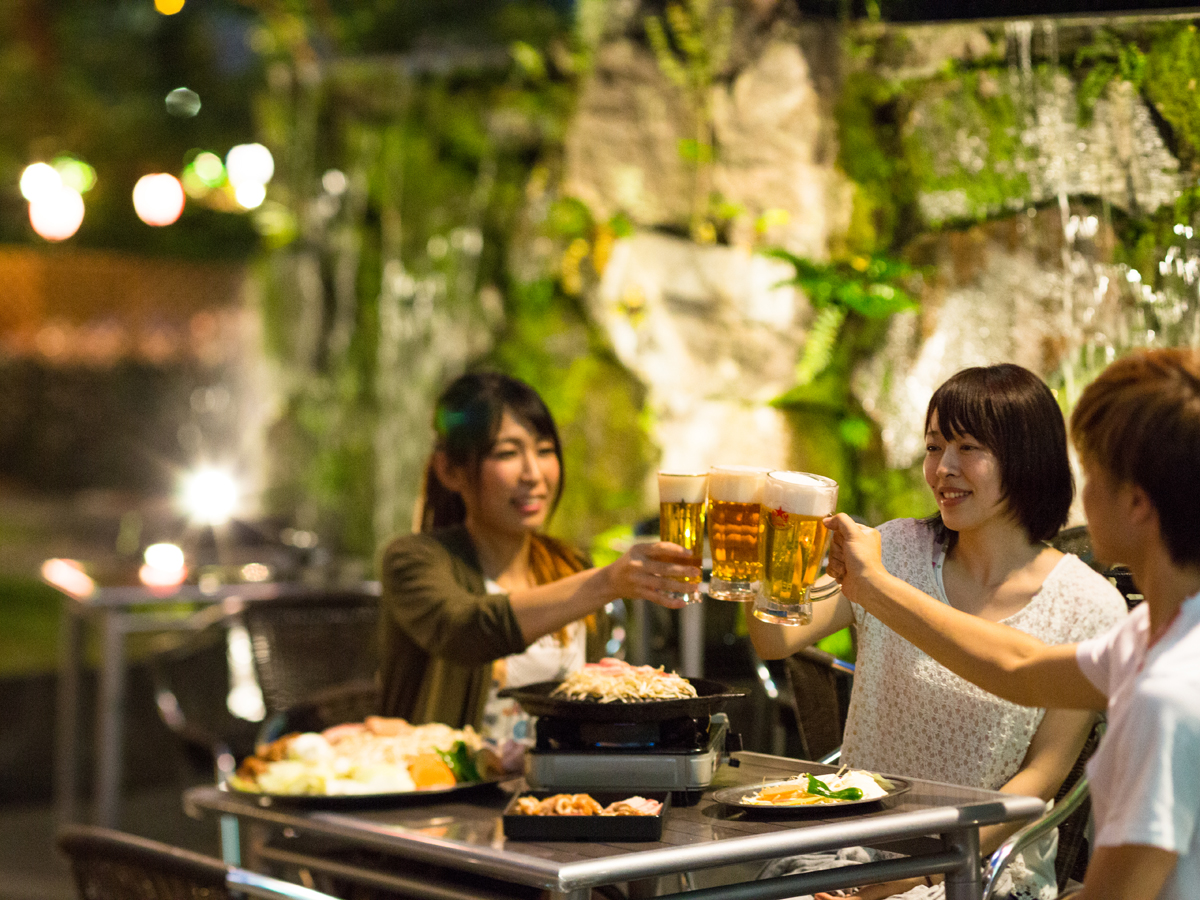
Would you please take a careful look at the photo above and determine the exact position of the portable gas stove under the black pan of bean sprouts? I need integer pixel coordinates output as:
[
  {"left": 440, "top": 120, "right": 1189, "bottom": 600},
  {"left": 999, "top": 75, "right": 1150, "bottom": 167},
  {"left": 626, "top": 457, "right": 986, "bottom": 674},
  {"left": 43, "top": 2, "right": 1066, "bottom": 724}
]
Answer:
[{"left": 526, "top": 713, "right": 740, "bottom": 792}]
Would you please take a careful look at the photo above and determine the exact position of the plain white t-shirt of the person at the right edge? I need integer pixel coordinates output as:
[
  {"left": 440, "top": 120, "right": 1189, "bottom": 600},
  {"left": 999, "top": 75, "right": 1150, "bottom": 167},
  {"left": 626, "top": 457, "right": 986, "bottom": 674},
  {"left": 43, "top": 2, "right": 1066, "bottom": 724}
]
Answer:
[{"left": 1075, "top": 594, "right": 1200, "bottom": 900}]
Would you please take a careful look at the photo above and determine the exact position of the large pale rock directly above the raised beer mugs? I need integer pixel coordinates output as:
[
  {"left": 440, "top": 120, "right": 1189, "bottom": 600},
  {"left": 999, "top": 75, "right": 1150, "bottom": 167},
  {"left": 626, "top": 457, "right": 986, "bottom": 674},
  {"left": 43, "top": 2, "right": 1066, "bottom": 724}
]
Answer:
[{"left": 590, "top": 233, "right": 811, "bottom": 480}]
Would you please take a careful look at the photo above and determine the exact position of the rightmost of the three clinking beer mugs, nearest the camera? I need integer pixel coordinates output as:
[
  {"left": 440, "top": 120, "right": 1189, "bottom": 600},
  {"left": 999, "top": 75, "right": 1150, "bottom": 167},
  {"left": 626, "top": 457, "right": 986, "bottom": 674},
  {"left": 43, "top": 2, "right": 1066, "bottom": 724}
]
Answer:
[{"left": 754, "top": 472, "right": 838, "bottom": 625}]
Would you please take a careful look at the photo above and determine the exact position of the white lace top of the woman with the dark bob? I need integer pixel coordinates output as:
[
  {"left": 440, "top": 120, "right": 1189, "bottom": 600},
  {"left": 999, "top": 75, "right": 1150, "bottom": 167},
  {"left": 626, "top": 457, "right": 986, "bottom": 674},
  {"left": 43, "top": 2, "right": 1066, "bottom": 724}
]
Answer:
[{"left": 841, "top": 518, "right": 1126, "bottom": 898}]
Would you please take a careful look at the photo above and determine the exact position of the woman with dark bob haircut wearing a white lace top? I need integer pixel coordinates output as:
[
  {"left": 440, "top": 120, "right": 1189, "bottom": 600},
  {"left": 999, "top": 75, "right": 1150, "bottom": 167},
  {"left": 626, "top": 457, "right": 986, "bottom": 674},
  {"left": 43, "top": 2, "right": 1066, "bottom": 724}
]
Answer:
[{"left": 750, "top": 364, "right": 1126, "bottom": 900}]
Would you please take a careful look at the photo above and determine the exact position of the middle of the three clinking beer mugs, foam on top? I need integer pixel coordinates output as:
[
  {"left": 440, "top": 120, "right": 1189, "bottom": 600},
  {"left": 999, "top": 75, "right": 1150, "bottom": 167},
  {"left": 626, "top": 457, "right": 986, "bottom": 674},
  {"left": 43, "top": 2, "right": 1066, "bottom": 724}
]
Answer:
[{"left": 708, "top": 466, "right": 769, "bottom": 604}]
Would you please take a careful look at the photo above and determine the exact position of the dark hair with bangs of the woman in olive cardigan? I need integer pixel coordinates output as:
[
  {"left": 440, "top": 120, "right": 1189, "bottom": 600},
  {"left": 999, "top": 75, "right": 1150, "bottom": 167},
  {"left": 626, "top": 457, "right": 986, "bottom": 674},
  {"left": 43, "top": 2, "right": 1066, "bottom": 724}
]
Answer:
[{"left": 421, "top": 372, "right": 564, "bottom": 532}]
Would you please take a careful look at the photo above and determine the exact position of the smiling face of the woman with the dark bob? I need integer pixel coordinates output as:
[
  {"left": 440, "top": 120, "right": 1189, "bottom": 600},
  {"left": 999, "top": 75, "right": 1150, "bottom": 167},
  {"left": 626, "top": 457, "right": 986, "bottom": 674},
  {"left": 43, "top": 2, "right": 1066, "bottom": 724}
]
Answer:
[{"left": 924, "top": 410, "right": 1008, "bottom": 533}]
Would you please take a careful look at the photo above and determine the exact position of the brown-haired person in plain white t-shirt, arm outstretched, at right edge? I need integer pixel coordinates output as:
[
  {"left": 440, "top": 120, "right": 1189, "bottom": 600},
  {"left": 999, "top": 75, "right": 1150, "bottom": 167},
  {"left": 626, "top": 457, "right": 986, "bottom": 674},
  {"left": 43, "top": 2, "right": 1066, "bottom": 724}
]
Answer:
[{"left": 827, "top": 349, "right": 1200, "bottom": 900}]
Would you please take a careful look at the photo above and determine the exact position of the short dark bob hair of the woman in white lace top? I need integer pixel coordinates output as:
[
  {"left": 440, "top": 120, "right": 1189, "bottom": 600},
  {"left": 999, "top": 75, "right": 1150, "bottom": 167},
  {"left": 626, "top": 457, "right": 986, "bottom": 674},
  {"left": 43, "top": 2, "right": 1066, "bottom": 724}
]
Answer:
[{"left": 925, "top": 362, "right": 1075, "bottom": 548}]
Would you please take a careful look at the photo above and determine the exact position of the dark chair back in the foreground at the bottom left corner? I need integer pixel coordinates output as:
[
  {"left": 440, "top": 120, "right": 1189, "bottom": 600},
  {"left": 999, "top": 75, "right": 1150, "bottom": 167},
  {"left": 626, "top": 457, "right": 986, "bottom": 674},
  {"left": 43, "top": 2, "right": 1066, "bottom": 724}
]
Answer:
[{"left": 58, "top": 826, "right": 335, "bottom": 900}]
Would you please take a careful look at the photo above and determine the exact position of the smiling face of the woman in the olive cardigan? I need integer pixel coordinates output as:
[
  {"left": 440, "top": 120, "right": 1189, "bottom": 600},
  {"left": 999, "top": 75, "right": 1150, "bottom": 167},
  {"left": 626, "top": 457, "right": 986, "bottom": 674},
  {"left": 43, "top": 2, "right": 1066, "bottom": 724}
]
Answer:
[{"left": 448, "top": 410, "right": 562, "bottom": 536}]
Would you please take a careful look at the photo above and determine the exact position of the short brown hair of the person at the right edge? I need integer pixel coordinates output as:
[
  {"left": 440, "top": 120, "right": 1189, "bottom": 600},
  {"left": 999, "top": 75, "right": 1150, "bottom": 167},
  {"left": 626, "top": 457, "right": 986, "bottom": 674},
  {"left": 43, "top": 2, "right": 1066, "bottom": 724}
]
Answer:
[{"left": 1070, "top": 349, "right": 1200, "bottom": 565}]
